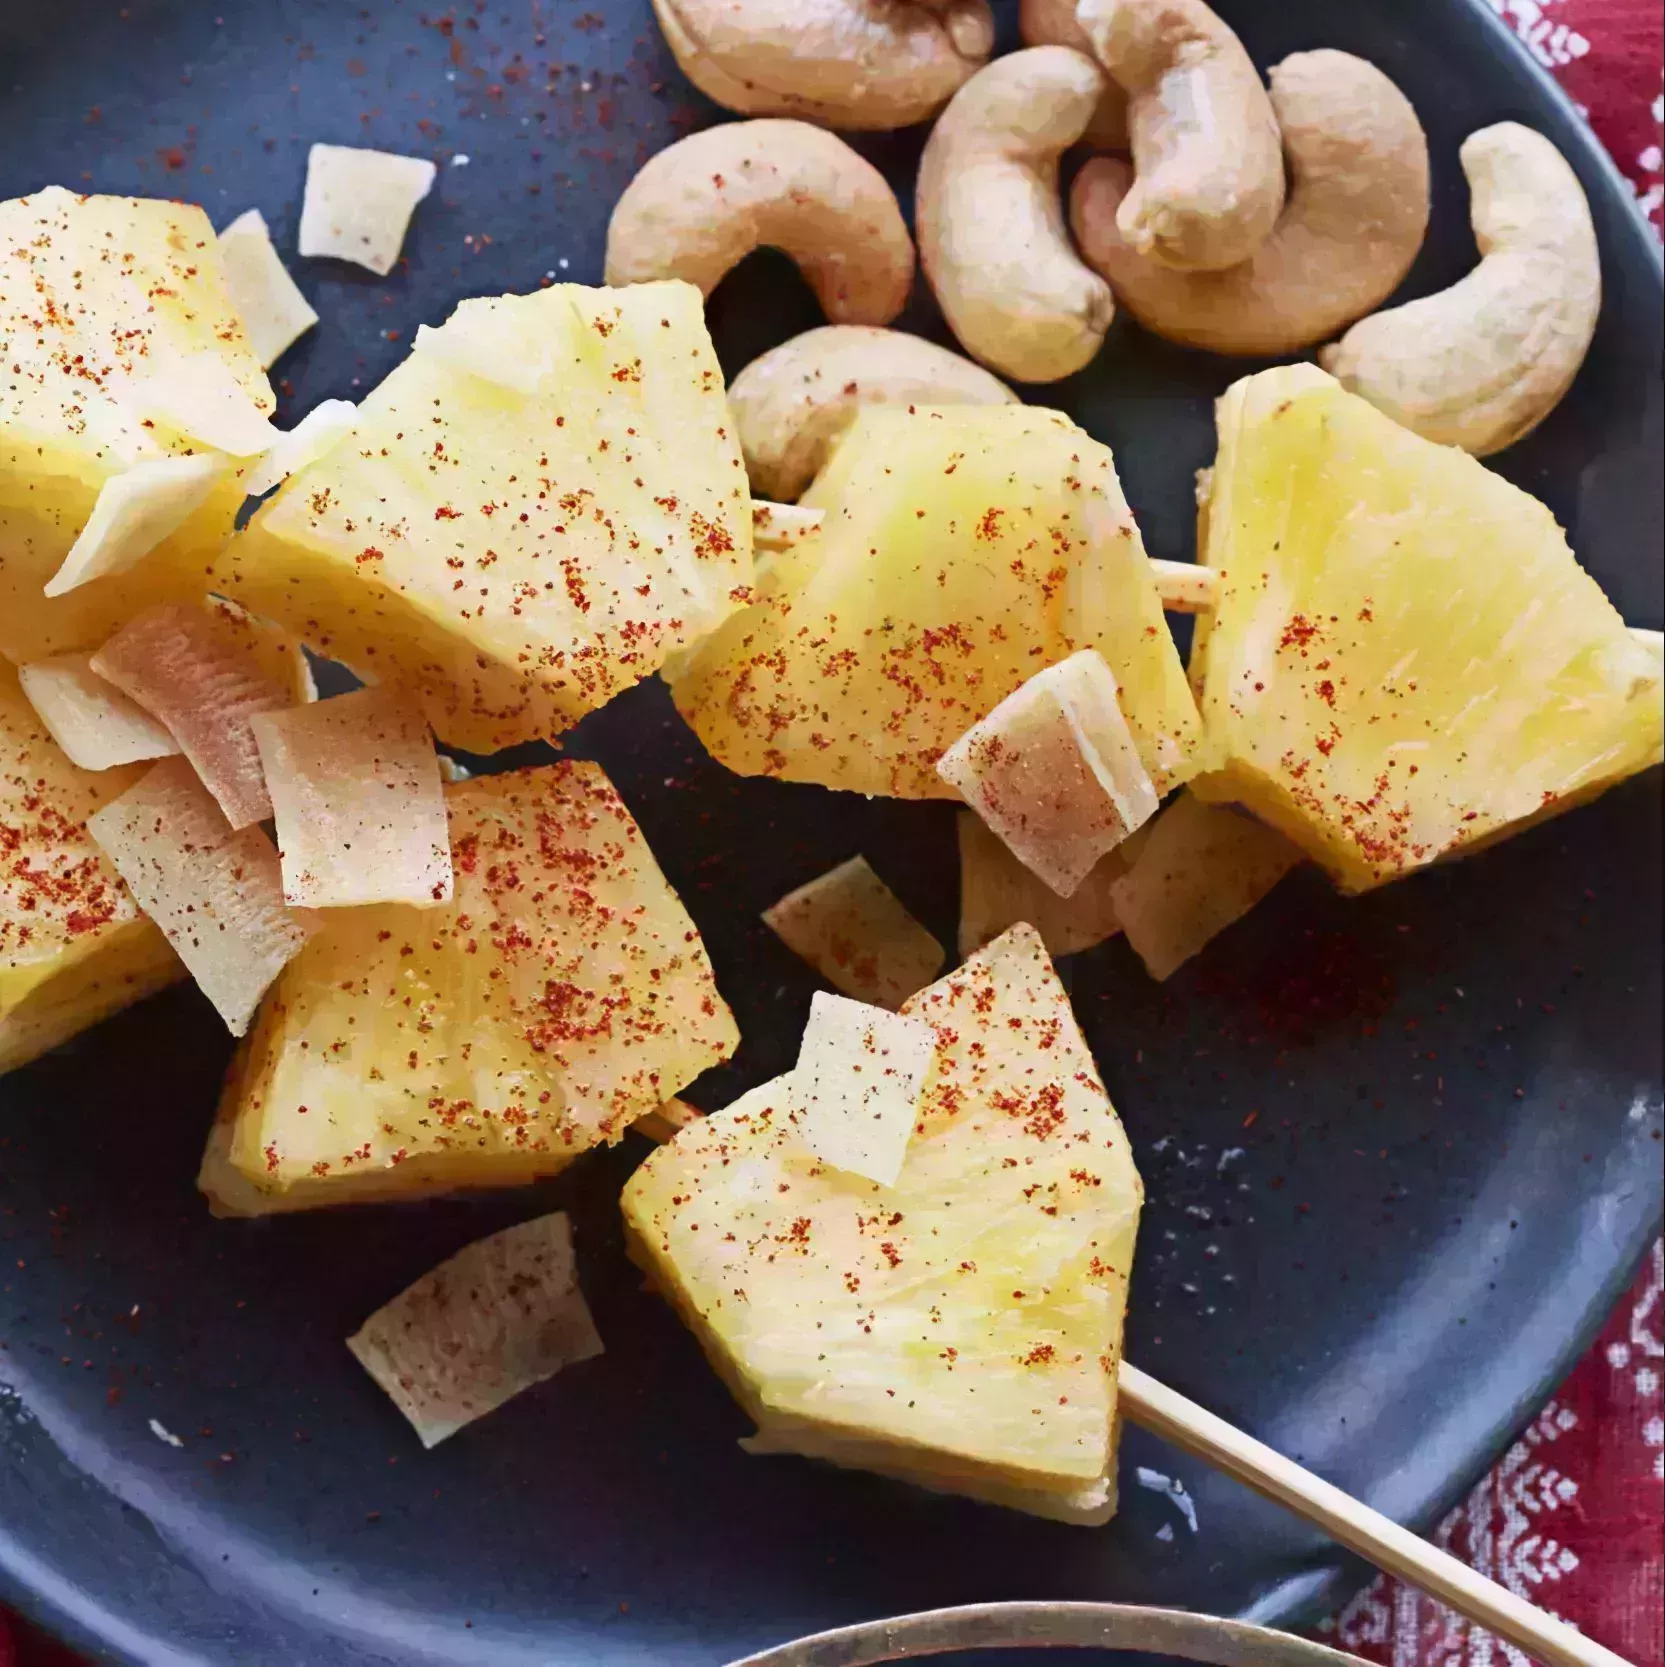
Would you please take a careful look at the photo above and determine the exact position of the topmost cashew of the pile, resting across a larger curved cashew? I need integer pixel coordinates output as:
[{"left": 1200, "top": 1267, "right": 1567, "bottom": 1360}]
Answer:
[{"left": 1075, "top": 0, "right": 1283, "bottom": 272}]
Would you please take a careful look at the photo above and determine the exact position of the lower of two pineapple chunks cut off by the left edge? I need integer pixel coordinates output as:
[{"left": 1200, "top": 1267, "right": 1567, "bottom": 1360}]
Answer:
[{"left": 0, "top": 665, "right": 185, "bottom": 1072}]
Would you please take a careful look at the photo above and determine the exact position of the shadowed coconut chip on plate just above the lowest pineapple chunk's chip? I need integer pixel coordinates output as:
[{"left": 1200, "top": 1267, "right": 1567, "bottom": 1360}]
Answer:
[{"left": 763, "top": 857, "right": 947, "bottom": 1007}]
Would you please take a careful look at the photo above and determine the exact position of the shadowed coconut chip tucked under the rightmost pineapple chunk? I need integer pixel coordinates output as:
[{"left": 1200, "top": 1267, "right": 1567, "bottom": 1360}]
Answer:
[{"left": 1110, "top": 792, "right": 1303, "bottom": 979}]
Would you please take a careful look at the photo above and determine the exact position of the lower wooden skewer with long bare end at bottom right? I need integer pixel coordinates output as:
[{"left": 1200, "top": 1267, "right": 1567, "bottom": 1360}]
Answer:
[{"left": 632, "top": 1100, "right": 1630, "bottom": 1667}]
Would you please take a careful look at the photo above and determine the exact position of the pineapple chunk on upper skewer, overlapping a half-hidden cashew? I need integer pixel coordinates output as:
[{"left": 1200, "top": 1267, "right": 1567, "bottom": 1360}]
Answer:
[{"left": 668, "top": 405, "right": 1203, "bottom": 798}]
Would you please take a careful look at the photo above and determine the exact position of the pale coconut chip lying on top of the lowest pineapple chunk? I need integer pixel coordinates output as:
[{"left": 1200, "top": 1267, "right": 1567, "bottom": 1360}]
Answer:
[{"left": 788, "top": 990, "right": 937, "bottom": 1187}]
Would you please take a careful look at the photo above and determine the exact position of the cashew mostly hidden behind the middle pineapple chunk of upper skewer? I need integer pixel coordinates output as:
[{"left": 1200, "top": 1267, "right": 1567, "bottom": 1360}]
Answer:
[{"left": 728, "top": 323, "right": 1017, "bottom": 498}]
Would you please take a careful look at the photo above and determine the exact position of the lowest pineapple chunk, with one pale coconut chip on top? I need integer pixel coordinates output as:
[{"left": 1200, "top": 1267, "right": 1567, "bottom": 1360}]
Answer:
[{"left": 623, "top": 927, "right": 1142, "bottom": 1522}]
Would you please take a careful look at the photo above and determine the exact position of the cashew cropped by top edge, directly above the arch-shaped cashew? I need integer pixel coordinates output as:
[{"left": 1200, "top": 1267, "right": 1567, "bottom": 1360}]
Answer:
[{"left": 653, "top": 0, "right": 995, "bottom": 128}]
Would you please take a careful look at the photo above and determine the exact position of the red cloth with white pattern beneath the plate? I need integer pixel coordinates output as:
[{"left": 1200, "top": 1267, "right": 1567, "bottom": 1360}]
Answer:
[{"left": 0, "top": 0, "right": 1665, "bottom": 1667}]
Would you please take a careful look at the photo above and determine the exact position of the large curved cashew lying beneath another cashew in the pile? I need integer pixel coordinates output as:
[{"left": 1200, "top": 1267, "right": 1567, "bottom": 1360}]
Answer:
[{"left": 1070, "top": 50, "right": 1428, "bottom": 355}]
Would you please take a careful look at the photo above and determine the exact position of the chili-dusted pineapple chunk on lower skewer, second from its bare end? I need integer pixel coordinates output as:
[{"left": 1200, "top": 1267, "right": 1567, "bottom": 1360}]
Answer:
[{"left": 200, "top": 763, "right": 738, "bottom": 1215}]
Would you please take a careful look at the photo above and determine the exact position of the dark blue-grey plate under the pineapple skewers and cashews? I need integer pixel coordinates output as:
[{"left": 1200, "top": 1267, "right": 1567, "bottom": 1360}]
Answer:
[{"left": 0, "top": 0, "right": 1662, "bottom": 1667}]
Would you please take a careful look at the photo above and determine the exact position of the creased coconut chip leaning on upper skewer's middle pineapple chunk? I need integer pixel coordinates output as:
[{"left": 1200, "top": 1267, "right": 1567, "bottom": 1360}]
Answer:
[{"left": 937, "top": 650, "right": 1158, "bottom": 897}]
